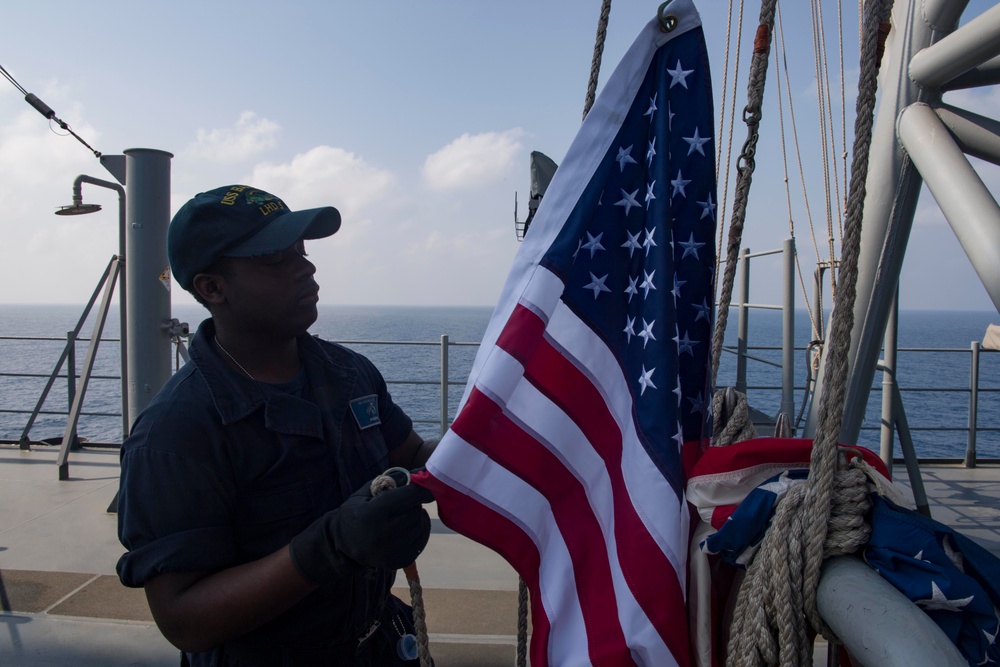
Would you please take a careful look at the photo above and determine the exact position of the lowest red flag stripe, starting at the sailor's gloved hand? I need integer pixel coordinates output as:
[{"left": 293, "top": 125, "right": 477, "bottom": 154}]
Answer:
[{"left": 410, "top": 470, "right": 551, "bottom": 667}]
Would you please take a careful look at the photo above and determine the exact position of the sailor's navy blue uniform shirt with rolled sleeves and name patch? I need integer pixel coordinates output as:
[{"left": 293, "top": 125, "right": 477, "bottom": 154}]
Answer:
[{"left": 117, "top": 319, "right": 412, "bottom": 648}]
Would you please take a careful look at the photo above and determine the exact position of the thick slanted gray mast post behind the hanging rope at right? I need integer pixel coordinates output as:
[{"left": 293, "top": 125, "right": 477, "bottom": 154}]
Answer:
[{"left": 804, "top": 0, "right": 968, "bottom": 443}]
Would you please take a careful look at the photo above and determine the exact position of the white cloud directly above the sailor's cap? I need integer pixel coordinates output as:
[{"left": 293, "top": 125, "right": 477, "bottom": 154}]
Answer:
[{"left": 246, "top": 146, "right": 395, "bottom": 217}]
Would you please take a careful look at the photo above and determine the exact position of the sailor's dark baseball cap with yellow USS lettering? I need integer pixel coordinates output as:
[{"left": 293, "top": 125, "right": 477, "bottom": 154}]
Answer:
[{"left": 167, "top": 185, "right": 340, "bottom": 290}]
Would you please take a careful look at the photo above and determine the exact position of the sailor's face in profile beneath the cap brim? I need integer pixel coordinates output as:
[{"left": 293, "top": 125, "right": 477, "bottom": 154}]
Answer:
[{"left": 227, "top": 241, "right": 319, "bottom": 335}]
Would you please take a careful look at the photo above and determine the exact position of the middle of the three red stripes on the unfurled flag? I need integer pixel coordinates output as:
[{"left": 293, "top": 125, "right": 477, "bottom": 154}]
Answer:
[{"left": 452, "top": 389, "right": 635, "bottom": 665}]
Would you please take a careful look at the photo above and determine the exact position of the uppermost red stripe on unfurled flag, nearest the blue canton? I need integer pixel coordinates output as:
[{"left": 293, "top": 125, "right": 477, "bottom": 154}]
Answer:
[{"left": 498, "top": 306, "right": 689, "bottom": 664}]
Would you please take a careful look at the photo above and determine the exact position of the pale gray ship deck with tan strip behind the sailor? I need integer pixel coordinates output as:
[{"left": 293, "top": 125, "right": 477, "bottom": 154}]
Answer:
[{"left": 0, "top": 445, "right": 1000, "bottom": 667}]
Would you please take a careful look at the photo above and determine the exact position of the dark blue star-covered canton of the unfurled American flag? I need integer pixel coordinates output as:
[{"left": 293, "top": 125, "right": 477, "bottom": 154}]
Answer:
[{"left": 540, "top": 31, "right": 716, "bottom": 493}]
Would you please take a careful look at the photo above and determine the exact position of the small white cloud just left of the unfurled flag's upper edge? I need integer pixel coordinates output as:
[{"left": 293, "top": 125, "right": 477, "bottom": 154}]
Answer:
[{"left": 423, "top": 128, "right": 523, "bottom": 190}]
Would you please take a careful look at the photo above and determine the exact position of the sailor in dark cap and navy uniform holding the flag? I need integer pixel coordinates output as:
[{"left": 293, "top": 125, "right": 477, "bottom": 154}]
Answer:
[{"left": 117, "top": 185, "right": 436, "bottom": 666}]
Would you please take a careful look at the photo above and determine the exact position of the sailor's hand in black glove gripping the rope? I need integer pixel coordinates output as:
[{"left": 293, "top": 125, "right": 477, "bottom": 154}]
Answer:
[{"left": 289, "top": 474, "right": 434, "bottom": 584}]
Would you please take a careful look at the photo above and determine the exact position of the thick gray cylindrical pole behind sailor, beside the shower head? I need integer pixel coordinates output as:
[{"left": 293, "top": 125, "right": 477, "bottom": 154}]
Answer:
[{"left": 125, "top": 148, "right": 173, "bottom": 425}]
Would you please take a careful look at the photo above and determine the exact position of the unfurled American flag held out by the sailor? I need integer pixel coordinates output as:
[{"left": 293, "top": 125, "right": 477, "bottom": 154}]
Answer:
[{"left": 416, "top": 0, "right": 716, "bottom": 667}]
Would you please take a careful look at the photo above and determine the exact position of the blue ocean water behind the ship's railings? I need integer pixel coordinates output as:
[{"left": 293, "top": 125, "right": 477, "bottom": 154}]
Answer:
[{"left": 0, "top": 305, "right": 1000, "bottom": 458}]
